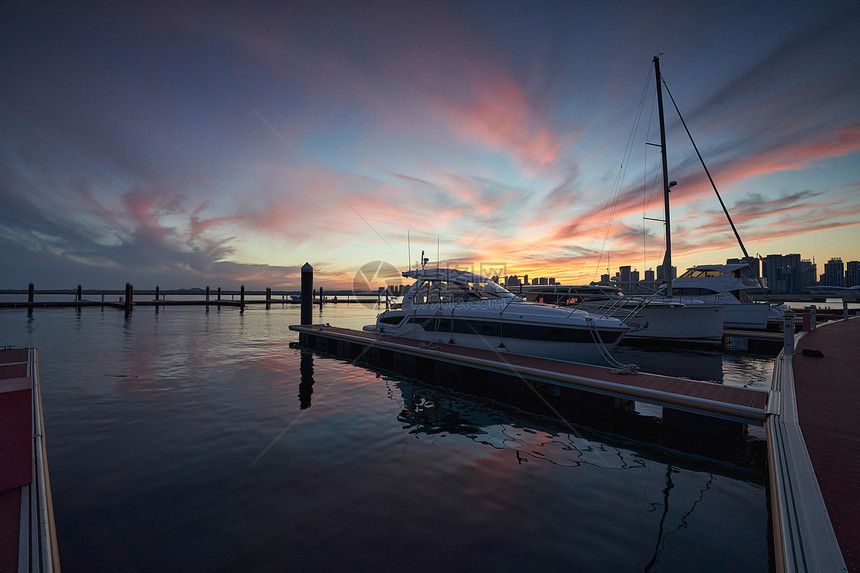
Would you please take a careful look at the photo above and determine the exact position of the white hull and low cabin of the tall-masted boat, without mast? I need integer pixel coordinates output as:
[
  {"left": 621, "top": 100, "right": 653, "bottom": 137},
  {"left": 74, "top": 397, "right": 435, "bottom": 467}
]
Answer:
[{"left": 525, "top": 285, "right": 723, "bottom": 344}]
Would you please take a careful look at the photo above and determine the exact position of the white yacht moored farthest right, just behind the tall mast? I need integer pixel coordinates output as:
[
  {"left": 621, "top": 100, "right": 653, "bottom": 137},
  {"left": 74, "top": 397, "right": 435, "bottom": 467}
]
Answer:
[{"left": 658, "top": 263, "right": 778, "bottom": 330}]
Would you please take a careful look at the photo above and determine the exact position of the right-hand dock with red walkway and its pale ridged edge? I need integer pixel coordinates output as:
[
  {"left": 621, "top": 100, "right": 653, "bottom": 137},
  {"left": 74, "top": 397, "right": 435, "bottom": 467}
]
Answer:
[{"left": 765, "top": 318, "right": 860, "bottom": 572}]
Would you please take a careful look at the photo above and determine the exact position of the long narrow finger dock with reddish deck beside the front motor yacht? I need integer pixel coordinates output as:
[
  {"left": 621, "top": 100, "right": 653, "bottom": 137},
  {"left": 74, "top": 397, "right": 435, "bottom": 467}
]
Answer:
[{"left": 290, "top": 325, "right": 767, "bottom": 431}]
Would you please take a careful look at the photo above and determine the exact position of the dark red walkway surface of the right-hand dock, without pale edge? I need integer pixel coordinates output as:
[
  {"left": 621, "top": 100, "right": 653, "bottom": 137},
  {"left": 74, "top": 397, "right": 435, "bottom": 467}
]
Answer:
[{"left": 792, "top": 319, "right": 860, "bottom": 572}]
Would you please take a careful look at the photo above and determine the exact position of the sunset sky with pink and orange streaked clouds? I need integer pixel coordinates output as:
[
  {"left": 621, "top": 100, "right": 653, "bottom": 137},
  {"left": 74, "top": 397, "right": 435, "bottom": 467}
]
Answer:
[{"left": 0, "top": 0, "right": 860, "bottom": 289}]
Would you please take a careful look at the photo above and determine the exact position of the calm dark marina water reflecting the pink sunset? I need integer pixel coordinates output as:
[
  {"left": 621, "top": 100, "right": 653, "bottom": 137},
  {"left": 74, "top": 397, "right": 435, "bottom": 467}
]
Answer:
[{"left": 0, "top": 306, "right": 770, "bottom": 572}]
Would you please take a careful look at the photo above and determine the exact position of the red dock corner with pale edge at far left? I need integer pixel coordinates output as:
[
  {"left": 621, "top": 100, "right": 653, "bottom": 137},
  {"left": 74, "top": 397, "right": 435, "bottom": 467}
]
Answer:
[{"left": 0, "top": 348, "right": 60, "bottom": 571}]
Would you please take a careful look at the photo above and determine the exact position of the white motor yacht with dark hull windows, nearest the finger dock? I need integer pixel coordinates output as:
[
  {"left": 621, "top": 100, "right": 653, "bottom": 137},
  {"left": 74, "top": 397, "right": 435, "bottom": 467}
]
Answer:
[{"left": 364, "top": 269, "right": 628, "bottom": 363}]
